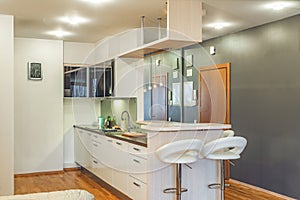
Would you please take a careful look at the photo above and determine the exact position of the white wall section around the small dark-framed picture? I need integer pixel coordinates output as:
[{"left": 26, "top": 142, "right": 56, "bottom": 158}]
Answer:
[{"left": 14, "top": 38, "right": 63, "bottom": 174}]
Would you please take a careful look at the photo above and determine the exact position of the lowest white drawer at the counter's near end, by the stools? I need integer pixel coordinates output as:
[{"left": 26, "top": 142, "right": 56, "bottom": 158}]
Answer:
[{"left": 128, "top": 176, "right": 147, "bottom": 200}]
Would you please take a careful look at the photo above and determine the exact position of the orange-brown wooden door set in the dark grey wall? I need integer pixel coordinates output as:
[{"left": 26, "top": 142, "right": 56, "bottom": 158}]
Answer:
[{"left": 198, "top": 63, "right": 230, "bottom": 124}]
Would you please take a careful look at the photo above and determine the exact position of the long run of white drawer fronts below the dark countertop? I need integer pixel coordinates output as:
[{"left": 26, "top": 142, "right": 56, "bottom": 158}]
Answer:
[{"left": 75, "top": 128, "right": 147, "bottom": 200}]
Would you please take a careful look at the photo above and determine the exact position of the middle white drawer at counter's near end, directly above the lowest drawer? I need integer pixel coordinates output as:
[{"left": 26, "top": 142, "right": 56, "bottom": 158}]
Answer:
[{"left": 129, "top": 154, "right": 147, "bottom": 183}]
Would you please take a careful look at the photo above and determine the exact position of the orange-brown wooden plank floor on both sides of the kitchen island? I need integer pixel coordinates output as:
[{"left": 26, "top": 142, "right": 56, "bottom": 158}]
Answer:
[{"left": 15, "top": 170, "right": 288, "bottom": 200}]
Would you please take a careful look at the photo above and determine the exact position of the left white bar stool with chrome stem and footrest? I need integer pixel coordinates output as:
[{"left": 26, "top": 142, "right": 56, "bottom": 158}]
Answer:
[{"left": 156, "top": 139, "right": 203, "bottom": 200}]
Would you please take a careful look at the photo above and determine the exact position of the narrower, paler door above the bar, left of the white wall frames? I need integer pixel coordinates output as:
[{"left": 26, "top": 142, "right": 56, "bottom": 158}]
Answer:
[{"left": 151, "top": 75, "right": 167, "bottom": 120}]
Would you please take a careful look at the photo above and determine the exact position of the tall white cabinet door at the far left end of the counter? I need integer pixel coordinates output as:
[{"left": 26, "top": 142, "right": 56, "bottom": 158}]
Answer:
[{"left": 74, "top": 128, "right": 92, "bottom": 168}]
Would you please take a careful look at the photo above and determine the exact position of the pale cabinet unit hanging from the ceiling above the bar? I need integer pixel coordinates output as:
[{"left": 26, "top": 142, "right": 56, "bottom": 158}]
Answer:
[{"left": 120, "top": 0, "right": 202, "bottom": 58}]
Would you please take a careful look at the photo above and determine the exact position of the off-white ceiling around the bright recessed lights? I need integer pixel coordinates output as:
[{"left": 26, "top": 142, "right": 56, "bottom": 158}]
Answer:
[{"left": 0, "top": 0, "right": 300, "bottom": 42}]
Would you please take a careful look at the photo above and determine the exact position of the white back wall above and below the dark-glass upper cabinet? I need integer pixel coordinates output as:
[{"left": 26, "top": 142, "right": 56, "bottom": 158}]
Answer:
[{"left": 63, "top": 42, "right": 95, "bottom": 168}]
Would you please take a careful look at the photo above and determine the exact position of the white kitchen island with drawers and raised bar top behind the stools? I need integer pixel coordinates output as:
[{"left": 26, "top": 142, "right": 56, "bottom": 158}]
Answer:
[{"left": 75, "top": 122, "right": 231, "bottom": 200}]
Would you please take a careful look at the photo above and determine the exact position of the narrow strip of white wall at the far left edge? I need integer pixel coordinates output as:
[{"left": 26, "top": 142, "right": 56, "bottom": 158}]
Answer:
[{"left": 0, "top": 15, "right": 14, "bottom": 196}]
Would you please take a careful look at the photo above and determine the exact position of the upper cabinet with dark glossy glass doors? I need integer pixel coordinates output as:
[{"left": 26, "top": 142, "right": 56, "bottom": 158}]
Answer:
[{"left": 64, "top": 60, "right": 114, "bottom": 97}]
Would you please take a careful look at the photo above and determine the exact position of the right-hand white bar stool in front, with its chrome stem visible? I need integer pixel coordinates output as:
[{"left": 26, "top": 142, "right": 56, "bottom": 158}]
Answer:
[{"left": 202, "top": 136, "right": 247, "bottom": 200}]
